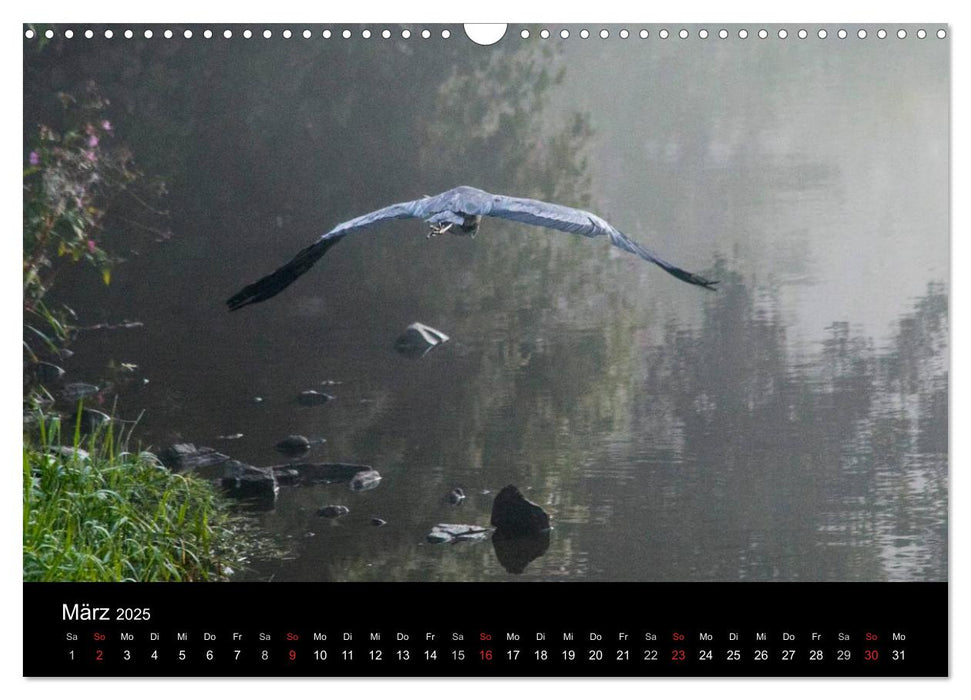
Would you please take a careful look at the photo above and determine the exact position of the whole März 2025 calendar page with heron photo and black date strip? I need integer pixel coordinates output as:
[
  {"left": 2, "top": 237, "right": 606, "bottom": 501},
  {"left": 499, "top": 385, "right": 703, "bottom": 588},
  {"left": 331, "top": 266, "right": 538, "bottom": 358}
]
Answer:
[{"left": 22, "top": 23, "right": 951, "bottom": 678}]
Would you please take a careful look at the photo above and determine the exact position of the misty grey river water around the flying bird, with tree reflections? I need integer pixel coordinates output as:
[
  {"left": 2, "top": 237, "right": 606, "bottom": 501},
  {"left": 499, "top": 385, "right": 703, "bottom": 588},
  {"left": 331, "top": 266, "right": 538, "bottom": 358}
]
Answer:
[{"left": 24, "top": 27, "right": 949, "bottom": 581}]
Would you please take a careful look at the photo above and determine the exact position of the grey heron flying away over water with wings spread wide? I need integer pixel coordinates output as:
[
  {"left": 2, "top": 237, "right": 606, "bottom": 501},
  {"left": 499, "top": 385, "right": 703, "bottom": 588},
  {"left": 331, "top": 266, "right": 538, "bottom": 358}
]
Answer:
[{"left": 226, "top": 187, "right": 718, "bottom": 311}]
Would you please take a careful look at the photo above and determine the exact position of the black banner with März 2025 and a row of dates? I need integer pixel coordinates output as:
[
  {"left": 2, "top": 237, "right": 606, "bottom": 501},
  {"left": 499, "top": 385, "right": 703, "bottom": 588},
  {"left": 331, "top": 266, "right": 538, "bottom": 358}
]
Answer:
[{"left": 24, "top": 583, "right": 948, "bottom": 677}]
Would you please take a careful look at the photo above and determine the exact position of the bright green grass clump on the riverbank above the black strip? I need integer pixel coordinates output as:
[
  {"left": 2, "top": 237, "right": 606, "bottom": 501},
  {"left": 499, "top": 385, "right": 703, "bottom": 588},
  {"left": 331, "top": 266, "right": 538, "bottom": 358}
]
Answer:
[{"left": 24, "top": 408, "right": 243, "bottom": 581}]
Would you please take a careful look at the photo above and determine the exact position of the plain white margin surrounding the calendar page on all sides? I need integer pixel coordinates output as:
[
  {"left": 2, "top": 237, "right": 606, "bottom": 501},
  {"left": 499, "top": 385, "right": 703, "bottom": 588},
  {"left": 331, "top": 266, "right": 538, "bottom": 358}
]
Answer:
[{"left": 0, "top": 0, "right": 971, "bottom": 700}]
